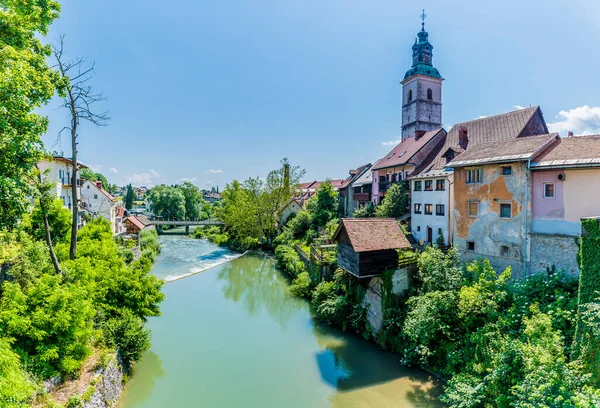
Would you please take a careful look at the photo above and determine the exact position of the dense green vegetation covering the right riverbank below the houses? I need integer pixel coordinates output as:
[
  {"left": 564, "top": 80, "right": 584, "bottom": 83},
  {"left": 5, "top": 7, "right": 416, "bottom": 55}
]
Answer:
[{"left": 274, "top": 184, "right": 600, "bottom": 408}]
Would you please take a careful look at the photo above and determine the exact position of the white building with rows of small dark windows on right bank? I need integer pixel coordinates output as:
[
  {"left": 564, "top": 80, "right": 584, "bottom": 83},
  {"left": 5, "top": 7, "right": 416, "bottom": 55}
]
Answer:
[{"left": 411, "top": 170, "right": 454, "bottom": 245}]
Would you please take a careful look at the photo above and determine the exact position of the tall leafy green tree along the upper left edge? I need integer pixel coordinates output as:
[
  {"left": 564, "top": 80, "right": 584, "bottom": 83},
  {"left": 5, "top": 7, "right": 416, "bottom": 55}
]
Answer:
[{"left": 0, "top": 0, "right": 60, "bottom": 228}]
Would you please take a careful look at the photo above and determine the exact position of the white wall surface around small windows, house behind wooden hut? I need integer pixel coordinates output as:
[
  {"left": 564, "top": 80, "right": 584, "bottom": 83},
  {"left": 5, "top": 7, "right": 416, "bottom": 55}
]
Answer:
[{"left": 410, "top": 177, "right": 451, "bottom": 245}]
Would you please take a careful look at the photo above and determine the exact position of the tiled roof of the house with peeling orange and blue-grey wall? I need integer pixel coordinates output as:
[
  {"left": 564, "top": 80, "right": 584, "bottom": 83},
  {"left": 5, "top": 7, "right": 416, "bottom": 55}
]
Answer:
[{"left": 448, "top": 133, "right": 560, "bottom": 167}]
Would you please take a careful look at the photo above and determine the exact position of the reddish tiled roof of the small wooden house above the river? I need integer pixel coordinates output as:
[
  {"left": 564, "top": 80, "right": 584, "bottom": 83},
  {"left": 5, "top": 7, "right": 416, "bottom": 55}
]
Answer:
[{"left": 334, "top": 218, "right": 410, "bottom": 252}]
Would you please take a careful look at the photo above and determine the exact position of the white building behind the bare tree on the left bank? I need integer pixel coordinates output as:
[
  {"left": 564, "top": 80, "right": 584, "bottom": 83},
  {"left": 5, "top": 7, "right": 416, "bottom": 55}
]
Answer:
[{"left": 38, "top": 156, "right": 87, "bottom": 228}]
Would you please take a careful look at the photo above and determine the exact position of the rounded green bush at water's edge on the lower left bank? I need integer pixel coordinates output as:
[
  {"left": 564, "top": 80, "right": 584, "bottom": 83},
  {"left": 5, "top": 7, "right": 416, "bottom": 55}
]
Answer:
[{"left": 104, "top": 311, "right": 150, "bottom": 369}]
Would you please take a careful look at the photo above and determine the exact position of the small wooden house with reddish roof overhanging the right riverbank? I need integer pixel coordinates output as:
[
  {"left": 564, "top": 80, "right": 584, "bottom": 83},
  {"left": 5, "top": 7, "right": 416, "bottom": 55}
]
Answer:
[{"left": 334, "top": 218, "right": 411, "bottom": 278}]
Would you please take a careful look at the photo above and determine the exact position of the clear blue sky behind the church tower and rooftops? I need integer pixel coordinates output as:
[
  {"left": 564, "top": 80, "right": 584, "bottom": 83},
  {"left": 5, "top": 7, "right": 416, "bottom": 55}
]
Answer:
[{"left": 42, "top": 0, "right": 600, "bottom": 189}]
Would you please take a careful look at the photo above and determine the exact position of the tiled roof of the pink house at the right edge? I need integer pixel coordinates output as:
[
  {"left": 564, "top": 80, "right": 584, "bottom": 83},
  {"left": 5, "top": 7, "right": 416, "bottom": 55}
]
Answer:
[{"left": 534, "top": 135, "right": 600, "bottom": 167}]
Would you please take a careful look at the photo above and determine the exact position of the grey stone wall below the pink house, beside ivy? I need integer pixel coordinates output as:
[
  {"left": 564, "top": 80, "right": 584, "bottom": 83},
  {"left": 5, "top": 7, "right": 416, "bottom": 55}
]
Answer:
[{"left": 529, "top": 234, "right": 579, "bottom": 275}]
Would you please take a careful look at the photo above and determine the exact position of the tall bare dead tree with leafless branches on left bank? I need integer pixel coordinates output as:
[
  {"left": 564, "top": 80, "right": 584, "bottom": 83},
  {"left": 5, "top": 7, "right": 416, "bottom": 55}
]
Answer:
[{"left": 52, "top": 34, "right": 110, "bottom": 259}]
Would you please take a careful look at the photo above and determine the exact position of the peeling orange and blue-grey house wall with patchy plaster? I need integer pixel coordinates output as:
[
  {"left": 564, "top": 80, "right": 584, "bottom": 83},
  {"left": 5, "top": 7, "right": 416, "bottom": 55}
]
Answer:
[{"left": 453, "top": 163, "right": 531, "bottom": 277}]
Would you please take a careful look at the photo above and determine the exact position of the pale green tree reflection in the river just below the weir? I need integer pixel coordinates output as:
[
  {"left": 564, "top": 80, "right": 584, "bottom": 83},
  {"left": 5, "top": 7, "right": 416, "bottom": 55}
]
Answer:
[{"left": 218, "top": 255, "right": 306, "bottom": 328}]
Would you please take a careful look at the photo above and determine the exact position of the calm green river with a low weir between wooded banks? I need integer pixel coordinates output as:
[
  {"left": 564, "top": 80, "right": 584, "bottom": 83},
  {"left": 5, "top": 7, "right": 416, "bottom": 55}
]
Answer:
[{"left": 119, "top": 236, "right": 441, "bottom": 408}]
